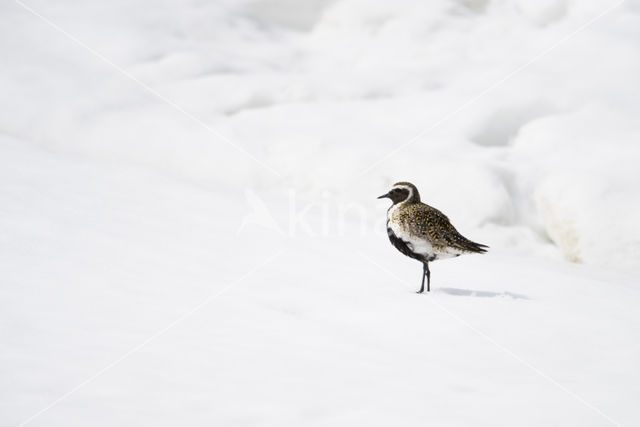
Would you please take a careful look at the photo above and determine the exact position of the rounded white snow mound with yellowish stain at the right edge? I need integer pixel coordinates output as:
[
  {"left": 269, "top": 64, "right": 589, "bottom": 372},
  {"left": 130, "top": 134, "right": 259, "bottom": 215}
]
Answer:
[{"left": 514, "top": 107, "right": 640, "bottom": 269}]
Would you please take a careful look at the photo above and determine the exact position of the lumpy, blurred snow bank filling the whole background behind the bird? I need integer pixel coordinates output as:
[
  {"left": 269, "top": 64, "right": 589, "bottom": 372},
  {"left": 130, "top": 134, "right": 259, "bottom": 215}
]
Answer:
[{"left": 0, "top": 0, "right": 640, "bottom": 269}]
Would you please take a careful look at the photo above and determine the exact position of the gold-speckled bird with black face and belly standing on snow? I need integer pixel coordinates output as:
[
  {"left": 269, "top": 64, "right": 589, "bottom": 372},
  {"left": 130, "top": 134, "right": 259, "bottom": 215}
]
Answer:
[{"left": 378, "top": 182, "right": 489, "bottom": 294}]
